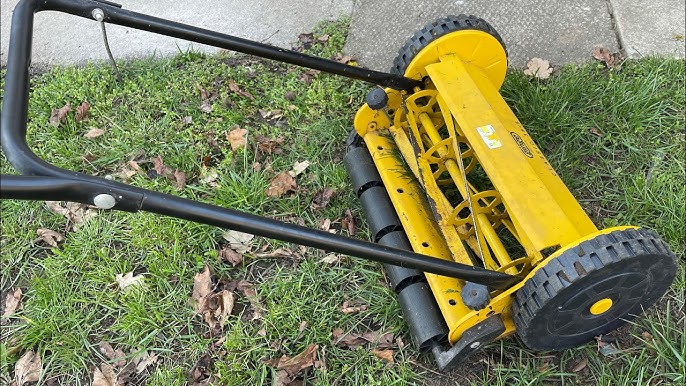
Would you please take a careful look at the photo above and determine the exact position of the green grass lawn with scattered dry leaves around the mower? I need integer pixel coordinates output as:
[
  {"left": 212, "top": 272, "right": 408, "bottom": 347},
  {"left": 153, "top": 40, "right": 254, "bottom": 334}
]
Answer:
[{"left": 0, "top": 17, "right": 686, "bottom": 385}]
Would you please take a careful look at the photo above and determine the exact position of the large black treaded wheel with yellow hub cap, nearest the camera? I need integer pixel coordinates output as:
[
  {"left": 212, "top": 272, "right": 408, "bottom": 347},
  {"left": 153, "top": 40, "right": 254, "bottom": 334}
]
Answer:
[{"left": 512, "top": 229, "right": 677, "bottom": 351}]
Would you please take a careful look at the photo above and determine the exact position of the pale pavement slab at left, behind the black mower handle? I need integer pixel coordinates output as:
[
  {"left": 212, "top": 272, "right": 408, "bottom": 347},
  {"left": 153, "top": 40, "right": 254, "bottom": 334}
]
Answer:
[{"left": 0, "top": 0, "right": 353, "bottom": 66}]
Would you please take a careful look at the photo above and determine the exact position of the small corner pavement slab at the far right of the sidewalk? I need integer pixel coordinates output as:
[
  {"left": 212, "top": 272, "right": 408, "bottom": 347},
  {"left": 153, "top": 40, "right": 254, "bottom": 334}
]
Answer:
[{"left": 610, "top": 0, "right": 686, "bottom": 58}]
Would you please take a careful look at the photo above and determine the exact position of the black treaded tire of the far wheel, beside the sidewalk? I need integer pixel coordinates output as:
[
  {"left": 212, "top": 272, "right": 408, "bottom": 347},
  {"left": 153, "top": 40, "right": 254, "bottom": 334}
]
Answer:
[{"left": 390, "top": 15, "right": 507, "bottom": 75}]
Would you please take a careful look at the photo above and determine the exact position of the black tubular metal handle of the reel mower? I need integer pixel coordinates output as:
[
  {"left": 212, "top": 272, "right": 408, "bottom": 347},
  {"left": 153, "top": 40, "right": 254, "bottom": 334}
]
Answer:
[{"left": 0, "top": 0, "right": 521, "bottom": 289}]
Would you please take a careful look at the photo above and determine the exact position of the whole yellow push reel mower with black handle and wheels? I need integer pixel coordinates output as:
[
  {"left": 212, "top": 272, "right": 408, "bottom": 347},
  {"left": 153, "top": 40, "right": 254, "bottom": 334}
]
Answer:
[{"left": 0, "top": 0, "right": 676, "bottom": 370}]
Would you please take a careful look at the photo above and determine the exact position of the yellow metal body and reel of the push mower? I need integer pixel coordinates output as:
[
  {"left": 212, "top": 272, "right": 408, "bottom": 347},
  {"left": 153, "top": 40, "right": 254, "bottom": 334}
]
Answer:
[{"left": 354, "top": 30, "right": 652, "bottom": 343}]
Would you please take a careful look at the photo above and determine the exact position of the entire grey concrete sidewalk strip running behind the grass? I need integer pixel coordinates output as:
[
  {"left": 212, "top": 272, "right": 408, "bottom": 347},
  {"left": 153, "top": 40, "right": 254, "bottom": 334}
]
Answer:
[{"left": 0, "top": 0, "right": 686, "bottom": 71}]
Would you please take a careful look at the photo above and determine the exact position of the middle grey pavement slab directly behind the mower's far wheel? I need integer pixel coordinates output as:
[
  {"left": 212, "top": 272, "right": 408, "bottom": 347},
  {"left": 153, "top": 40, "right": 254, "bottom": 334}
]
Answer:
[{"left": 346, "top": 0, "right": 620, "bottom": 71}]
